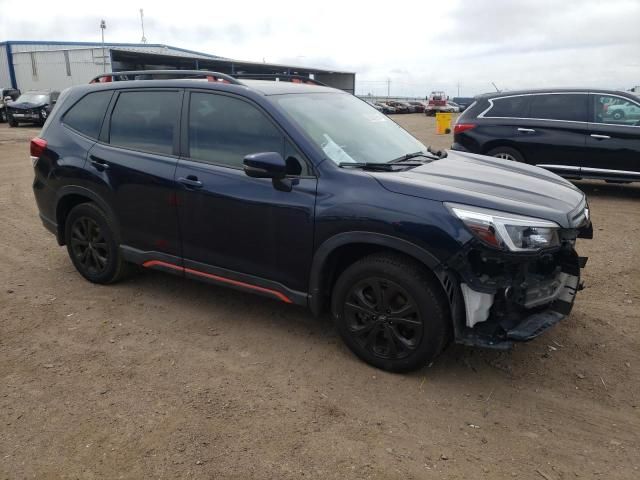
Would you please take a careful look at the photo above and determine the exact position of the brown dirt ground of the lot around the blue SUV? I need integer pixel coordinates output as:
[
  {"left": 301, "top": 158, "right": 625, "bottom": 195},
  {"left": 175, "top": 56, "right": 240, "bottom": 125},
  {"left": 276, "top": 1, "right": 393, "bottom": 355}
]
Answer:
[{"left": 0, "top": 114, "right": 640, "bottom": 480}]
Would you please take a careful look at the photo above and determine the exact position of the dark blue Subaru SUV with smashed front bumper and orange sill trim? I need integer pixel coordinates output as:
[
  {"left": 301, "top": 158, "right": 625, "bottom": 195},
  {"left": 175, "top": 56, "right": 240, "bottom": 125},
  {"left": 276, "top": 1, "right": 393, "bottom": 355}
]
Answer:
[{"left": 31, "top": 72, "right": 592, "bottom": 371}]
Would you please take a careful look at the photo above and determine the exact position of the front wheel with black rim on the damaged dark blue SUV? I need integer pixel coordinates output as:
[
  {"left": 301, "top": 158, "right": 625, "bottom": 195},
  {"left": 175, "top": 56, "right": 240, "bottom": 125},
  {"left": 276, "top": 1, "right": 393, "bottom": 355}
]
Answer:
[{"left": 331, "top": 253, "right": 451, "bottom": 372}]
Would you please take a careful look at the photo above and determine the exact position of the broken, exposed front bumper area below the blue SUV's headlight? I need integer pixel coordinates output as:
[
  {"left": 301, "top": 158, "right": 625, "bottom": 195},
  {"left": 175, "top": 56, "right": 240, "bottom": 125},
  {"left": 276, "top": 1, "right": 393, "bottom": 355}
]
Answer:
[{"left": 448, "top": 243, "right": 587, "bottom": 350}]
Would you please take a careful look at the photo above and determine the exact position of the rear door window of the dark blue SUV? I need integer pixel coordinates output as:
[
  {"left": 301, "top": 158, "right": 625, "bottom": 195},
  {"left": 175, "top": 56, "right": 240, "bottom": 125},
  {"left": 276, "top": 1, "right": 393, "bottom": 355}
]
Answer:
[{"left": 109, "top": 91, "right": 181, "bottom": 155}]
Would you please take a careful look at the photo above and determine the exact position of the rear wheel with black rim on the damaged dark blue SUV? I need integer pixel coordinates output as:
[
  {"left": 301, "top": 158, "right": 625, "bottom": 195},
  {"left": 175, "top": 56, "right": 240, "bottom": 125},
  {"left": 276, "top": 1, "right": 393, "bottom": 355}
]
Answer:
[{"left": 65, "top": 203, "right": 127, "bottom": 284}]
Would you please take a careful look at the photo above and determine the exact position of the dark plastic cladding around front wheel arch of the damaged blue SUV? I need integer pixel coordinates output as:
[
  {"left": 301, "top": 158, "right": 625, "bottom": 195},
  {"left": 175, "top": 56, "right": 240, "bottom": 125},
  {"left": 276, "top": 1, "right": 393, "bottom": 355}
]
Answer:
[{"left": 309, "top": 232, "right": 449, "bottom": 316}]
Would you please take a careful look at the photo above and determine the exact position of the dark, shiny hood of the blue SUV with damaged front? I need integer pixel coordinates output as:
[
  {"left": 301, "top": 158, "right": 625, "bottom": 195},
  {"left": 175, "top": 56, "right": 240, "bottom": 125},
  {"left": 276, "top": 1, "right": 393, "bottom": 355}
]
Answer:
[{"left": 368, "top": 150, "right": 586, "bottom": 228}]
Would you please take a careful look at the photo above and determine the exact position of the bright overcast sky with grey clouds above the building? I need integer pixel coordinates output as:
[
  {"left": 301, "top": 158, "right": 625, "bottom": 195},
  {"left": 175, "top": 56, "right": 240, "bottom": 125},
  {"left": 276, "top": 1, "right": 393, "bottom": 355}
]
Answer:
[{"left": 0, "top": 0, "right": 640, "bottom": 96}]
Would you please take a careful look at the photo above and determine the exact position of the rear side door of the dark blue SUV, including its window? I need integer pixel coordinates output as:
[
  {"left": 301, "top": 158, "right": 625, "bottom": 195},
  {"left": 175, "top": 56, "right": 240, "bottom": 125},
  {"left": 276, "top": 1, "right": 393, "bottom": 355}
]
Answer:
[{"left": 86, "top": 88, "right": 183, "bottom": 258}]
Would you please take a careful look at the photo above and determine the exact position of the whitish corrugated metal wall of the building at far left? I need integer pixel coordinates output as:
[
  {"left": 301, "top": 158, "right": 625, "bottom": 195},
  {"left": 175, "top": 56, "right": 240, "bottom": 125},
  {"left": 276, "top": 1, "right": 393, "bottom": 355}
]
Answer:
[{"left": 13, "top": 48, "right": 111, "bottom": 91}]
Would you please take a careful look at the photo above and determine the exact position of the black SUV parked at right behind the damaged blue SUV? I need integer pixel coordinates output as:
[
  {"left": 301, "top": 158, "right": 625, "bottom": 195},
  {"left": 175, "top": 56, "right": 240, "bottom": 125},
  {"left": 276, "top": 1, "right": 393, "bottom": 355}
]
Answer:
[{"left": 453, "top": 89, "right": 640, "bottom": 182}]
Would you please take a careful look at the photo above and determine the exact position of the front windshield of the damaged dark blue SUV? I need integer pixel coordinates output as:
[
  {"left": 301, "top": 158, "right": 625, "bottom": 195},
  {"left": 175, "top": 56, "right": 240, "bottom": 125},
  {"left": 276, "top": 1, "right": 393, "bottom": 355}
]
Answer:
[{"left": 272, "top": 93, "right": 427, "bottom": 164}]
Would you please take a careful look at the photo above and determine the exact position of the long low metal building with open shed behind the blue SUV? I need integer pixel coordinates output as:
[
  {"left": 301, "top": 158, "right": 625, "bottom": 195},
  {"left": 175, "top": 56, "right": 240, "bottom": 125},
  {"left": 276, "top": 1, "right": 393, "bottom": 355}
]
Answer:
[{"left": 0, "top": 41, "right": 355, "bottom": 93}]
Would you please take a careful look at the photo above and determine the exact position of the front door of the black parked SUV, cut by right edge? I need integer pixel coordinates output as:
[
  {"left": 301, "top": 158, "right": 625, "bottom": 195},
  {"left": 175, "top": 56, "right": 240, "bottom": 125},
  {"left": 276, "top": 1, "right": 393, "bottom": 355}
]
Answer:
[{"left": 582, "top": 93, "right": 640, "bottom": 180}]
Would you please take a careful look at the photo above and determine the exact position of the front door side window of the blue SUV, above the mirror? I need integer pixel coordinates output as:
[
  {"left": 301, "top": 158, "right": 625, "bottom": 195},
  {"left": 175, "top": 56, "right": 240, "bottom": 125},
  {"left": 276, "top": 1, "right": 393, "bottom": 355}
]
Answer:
[{"left": 189, "top": 92, "right": 285, "bottom": 168}]
